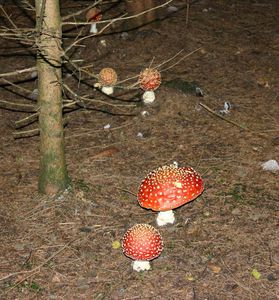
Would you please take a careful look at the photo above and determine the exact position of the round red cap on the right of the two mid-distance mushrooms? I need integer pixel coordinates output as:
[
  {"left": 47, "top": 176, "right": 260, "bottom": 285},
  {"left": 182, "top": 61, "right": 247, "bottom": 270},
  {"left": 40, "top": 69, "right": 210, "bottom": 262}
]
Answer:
[{"left": 139, "top": 68, "right": 161, "bottom": 91}]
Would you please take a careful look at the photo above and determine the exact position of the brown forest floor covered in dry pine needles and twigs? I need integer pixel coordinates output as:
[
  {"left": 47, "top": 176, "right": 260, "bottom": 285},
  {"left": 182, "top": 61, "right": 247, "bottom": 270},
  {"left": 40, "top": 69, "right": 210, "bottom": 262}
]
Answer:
[{"left": 0, "top": 0, "right": 279, "bottom": 300}]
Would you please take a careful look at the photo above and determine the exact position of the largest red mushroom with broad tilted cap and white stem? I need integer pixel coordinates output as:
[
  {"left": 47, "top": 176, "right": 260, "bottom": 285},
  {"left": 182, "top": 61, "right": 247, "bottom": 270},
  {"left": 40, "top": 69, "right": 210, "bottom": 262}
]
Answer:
[{"left": 138, "top": 164, "right": 204, "bottom": 226}]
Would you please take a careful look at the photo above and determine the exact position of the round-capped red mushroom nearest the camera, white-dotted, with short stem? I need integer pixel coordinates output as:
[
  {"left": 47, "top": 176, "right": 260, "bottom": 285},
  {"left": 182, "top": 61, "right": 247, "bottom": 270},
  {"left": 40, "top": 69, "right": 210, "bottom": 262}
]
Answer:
[{"left": 122, "top": 224, "right": 163, "bottom": 272}]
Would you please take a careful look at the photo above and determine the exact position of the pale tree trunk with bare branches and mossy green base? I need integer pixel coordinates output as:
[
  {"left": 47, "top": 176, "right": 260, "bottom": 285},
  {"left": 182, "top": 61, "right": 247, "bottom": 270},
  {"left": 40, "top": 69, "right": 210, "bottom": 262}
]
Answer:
[{"left": 36, "top": 0, "right": 70, "bottom": 195}]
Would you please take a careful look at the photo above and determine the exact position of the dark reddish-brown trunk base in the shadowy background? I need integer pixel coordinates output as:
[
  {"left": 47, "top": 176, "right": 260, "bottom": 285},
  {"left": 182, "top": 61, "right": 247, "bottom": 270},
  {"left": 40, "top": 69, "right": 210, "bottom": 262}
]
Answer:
[{"left": 126, "top": 0, "right": 158, "bottom": 29}]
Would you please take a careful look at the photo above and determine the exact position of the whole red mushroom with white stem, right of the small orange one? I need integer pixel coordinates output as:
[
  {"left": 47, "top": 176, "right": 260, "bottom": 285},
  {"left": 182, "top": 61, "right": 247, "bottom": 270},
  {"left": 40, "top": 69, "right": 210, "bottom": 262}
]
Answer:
[{"left": 139, "top": 68, "right": 161, "bottom": 104}]
